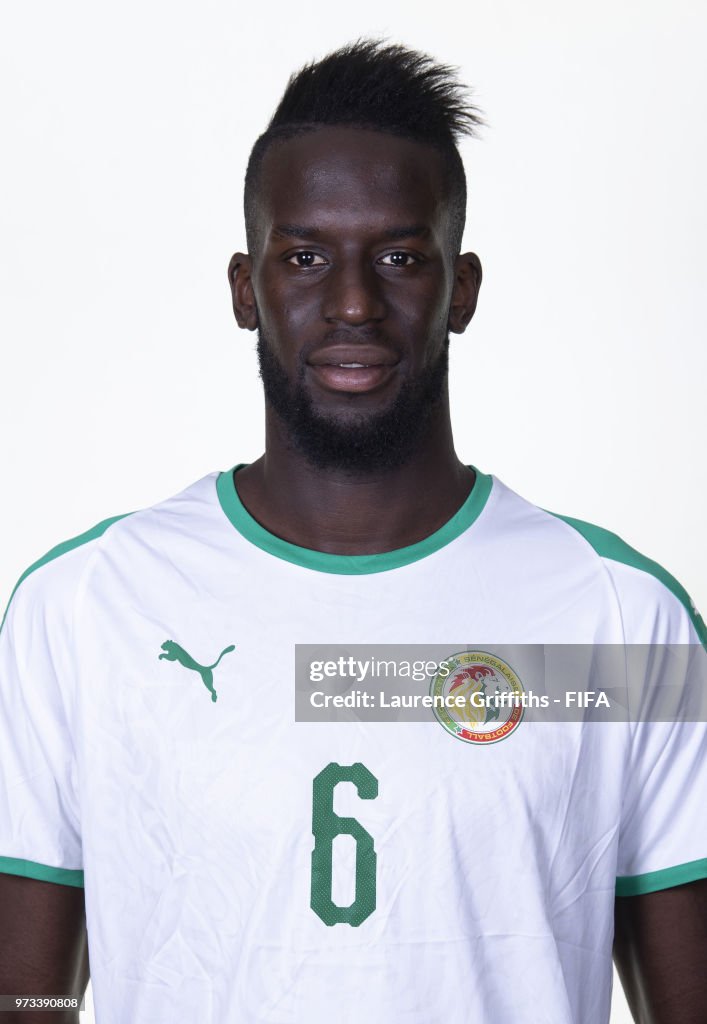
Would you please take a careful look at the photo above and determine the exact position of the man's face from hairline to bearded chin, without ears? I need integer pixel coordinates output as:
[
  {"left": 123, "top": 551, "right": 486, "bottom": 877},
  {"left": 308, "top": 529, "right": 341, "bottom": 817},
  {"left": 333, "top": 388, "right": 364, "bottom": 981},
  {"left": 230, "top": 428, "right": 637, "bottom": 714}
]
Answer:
[{"left": 233, "top": 127, "right": 475, "bottom": 470}]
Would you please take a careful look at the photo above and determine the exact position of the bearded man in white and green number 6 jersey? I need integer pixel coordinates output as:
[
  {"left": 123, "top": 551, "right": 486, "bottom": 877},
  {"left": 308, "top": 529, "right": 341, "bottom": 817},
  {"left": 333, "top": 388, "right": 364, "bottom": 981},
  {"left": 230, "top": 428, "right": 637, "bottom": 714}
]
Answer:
[{"left": 0, "top": 42, "right": 707, "bottom": 1024}]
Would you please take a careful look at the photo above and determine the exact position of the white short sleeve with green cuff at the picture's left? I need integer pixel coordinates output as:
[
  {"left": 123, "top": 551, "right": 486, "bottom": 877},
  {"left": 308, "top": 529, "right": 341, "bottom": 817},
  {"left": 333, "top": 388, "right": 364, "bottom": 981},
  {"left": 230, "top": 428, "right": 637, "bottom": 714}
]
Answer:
[{"left": 0, "top": 563, "right": 83, "bottom": 886}]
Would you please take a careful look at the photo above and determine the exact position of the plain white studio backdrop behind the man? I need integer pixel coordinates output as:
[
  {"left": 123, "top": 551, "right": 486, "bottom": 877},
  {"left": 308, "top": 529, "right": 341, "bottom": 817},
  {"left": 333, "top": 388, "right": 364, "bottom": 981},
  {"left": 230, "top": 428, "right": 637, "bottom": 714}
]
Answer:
[{"left": 0, "top": 0, "right": 707, "bottom": 1024}]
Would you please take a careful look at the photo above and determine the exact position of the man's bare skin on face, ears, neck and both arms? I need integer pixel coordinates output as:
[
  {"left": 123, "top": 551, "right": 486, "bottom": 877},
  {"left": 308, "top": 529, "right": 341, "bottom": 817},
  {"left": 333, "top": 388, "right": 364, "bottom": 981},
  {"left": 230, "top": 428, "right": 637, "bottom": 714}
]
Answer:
[{"left": 0, "top": 128, "right": 707, "bottom": 1024}]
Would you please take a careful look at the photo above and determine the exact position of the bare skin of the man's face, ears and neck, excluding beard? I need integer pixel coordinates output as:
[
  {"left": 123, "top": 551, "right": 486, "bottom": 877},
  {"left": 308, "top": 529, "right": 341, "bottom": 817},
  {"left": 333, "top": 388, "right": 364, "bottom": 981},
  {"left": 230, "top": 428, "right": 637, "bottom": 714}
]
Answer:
[{"left": 228, "top": 128, "right": 482, "bottom": 554}]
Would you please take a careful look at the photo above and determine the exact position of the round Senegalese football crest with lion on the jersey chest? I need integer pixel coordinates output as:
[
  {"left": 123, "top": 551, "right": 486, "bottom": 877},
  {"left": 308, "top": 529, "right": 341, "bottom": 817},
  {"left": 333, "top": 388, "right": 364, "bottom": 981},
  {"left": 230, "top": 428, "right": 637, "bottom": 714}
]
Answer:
[{"left": 429, "top": 650, "right": 525, "bottom": 745}]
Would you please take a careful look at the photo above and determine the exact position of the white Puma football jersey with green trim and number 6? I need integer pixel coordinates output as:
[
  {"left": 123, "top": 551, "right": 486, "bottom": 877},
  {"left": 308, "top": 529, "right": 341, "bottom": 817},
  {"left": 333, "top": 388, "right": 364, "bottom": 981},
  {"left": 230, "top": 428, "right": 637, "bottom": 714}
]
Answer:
[{"left": 0, "top": 467, "right": 707, "bottom": 1024}]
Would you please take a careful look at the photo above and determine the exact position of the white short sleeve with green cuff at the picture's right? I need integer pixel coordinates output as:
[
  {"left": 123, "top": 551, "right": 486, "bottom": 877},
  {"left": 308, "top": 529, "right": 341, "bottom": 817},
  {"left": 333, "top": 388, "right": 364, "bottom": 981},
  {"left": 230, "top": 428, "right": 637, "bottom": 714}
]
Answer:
[{"left": 616, "top": 568, "right": 707, "bottom": 896}]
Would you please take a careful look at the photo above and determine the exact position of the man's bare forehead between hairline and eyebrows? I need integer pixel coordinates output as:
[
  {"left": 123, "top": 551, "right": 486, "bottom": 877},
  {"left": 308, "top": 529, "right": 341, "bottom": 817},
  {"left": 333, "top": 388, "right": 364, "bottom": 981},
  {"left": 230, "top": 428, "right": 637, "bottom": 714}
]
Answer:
[{"left": 258, "top": 127, "right": 447, "bottom": 233}]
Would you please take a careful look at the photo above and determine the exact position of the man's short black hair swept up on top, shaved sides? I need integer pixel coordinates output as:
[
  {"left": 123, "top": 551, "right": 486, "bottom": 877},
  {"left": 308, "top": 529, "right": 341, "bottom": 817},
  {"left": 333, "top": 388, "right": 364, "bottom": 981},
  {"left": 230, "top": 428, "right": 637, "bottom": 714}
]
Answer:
[{"left": 244, "top": 39, "right": 485, "bottom": 256}]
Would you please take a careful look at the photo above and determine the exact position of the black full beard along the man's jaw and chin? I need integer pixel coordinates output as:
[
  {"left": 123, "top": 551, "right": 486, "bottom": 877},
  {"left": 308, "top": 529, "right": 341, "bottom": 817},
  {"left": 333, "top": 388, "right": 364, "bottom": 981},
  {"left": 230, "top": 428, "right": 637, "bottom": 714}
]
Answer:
[{"left": 257, "top": 330, "right": 449, "bottom": 473}]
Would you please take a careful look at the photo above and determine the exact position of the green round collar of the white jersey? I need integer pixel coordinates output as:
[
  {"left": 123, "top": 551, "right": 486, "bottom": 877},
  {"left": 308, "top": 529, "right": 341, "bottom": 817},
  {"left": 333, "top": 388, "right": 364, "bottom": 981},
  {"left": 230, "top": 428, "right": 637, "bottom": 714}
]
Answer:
[{"left": 216, "top": 463, "right": 493, "bottom": 575}]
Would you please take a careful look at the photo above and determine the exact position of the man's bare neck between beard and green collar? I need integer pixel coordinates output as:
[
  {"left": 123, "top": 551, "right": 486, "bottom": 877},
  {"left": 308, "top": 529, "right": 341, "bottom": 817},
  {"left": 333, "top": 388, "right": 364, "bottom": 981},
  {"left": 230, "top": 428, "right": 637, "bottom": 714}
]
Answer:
[{"left": 236, "top": 399, "right": 473, "bottom": 555}]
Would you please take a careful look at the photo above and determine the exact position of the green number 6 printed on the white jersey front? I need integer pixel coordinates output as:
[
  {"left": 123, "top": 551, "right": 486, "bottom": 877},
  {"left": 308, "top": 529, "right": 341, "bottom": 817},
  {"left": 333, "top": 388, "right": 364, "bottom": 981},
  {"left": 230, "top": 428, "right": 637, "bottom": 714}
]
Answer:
[{"left": 309, "top": 761, "right": 378, "bottom": 928}]
